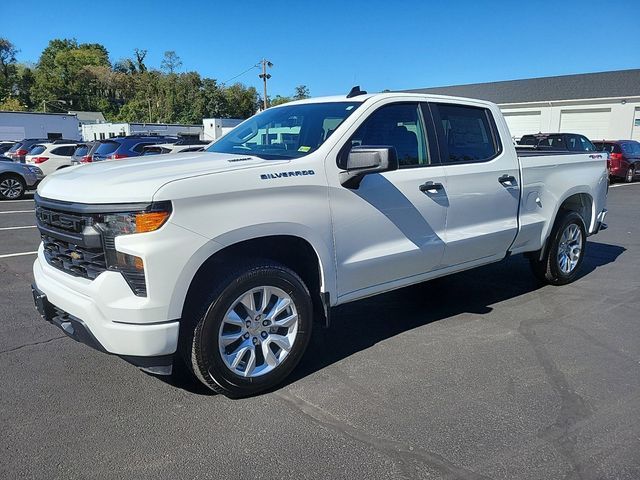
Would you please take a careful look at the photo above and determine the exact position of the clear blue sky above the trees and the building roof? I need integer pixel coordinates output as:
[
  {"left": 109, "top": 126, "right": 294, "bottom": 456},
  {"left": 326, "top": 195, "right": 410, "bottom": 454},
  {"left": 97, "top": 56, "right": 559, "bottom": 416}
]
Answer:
[{"left": 0, "top": 0, "right": 640, "bottom": 96}]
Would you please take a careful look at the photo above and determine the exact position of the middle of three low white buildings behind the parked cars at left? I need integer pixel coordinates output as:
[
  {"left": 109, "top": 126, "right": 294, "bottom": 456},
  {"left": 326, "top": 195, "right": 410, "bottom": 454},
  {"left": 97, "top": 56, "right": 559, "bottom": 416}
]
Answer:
[{"left": 82, "top": 123, "right": 203, "bottom": 142}]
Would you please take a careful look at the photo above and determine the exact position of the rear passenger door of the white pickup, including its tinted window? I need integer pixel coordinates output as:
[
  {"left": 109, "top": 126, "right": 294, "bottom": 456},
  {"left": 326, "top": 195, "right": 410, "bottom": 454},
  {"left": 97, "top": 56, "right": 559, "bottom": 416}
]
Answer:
[{"left": 429, "top": 103, "right": 520, "bottom": 266}]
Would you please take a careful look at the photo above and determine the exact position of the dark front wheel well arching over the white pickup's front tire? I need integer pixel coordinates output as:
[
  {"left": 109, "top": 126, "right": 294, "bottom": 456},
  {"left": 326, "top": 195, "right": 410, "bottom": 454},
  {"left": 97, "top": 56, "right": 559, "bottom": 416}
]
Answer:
[{"left": 182, "top": 235, "right": 328, "bottom": 323}]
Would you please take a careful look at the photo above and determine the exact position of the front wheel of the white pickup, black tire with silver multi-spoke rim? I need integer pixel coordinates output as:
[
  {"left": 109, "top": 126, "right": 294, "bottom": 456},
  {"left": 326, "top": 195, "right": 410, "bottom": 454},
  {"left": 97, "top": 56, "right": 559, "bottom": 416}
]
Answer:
[{"left": 180, "top": 260, "right": 313, "bottom": 398}]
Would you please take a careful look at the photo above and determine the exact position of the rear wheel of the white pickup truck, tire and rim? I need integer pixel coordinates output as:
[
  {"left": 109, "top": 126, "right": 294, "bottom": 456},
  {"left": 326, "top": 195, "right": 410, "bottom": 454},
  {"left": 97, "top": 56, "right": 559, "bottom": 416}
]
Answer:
[{"left": 529, "top": 211, "right": 587, "bottom": 285}]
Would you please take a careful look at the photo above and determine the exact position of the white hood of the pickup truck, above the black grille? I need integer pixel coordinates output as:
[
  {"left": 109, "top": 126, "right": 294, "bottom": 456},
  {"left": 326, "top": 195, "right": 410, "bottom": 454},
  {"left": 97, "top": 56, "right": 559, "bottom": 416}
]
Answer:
[{"left": 38, "top": 152, "right": 287, "bottom": 203}]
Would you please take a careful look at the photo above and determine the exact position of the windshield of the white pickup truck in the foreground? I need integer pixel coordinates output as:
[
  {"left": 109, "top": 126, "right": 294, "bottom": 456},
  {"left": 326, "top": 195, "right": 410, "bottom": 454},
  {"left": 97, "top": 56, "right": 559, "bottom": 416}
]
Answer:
[{"left": 207, "top": 102, "right": 360, "bottom": 160}]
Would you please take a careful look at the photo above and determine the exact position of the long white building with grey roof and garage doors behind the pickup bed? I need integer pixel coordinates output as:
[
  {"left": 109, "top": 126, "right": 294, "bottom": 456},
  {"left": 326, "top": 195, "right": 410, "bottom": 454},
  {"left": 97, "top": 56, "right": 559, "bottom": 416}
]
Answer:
[{"left": 409, "top": 69, "right": 640, "bottom": 141}]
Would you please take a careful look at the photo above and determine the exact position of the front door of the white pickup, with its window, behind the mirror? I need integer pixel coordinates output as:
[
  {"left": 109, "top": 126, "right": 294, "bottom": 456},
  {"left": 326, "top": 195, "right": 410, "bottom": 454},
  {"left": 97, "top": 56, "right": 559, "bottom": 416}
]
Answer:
[{"left": 329, "top": 102, "right": 447, "bottom": 298}]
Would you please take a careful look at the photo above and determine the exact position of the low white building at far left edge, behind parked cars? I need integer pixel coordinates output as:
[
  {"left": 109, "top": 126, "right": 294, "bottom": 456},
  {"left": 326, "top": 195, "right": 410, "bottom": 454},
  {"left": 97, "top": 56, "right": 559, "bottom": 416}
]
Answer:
[{"left": 0, "top": 112, "right": 80, "bottom": 140}]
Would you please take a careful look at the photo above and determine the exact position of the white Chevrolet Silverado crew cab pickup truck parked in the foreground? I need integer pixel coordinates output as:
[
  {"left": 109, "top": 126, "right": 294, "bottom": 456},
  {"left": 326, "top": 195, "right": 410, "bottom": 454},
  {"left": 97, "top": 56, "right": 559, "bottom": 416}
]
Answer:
[{"left": 33, "top": 87, "right": 608, "bottom": 397}]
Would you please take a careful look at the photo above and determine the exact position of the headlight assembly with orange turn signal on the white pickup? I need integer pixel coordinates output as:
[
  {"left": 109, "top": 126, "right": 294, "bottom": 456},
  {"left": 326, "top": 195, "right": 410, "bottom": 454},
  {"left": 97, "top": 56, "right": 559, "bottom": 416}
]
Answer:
[{"left": 95, "top": 202, "right": 171, "bottom": 297}]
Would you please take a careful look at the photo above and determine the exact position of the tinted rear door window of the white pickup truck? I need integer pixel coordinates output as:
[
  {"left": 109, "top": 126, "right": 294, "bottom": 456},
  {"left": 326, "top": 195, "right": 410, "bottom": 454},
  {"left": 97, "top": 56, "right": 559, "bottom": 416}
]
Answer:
[{"left": 431, "top": 103, "right": 502, "bottom": 163}]
